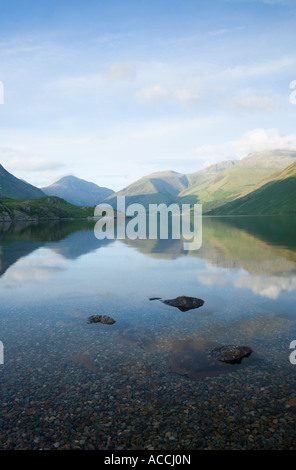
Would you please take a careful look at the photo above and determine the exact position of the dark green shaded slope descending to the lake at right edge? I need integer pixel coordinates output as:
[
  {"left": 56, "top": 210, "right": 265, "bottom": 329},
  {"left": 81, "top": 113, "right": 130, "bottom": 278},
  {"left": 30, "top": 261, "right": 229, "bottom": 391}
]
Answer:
[{"left": 209, "top": 162, "right": 296, "bottom": 215}]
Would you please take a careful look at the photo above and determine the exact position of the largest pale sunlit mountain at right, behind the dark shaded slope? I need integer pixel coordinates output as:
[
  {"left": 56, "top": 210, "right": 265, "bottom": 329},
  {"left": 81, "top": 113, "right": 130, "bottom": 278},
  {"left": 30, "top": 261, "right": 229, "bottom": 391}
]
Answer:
[{"left": 179, "top": 150, "right": 296, "bottom": 212}]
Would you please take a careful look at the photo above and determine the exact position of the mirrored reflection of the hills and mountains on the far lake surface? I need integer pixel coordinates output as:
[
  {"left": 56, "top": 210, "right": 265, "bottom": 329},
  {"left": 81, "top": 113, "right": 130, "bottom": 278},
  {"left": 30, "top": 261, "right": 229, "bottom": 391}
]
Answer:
[{"left": 0, "top": 217, "right": 296, "bottom": 280}]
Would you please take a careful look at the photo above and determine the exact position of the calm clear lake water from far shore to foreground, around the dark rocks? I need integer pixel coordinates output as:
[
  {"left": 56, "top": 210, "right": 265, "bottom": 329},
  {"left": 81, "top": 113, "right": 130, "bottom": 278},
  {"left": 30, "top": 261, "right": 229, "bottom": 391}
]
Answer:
[{"left": 0, "top": 217, "right": 296, "bottom": 449}]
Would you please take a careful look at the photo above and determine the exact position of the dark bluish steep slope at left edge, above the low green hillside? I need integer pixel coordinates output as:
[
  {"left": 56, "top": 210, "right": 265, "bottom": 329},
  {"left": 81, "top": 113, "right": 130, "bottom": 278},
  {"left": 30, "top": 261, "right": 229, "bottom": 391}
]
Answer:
[{"left": 0, "top": 165, "right": 44, "bottom": 199}]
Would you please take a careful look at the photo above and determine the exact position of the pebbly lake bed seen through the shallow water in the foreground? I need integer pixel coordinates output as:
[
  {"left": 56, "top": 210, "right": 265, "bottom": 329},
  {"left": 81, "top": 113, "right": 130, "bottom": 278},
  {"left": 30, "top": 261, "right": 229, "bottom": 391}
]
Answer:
[{"left": 0, "top": 306, "right": 296, "bottom": 450}]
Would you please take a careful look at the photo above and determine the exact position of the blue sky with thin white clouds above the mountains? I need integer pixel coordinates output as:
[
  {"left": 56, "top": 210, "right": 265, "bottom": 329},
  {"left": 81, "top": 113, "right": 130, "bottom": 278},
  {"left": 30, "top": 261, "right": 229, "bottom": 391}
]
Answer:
[{"left": 0, "top": 0, "right": 296, "bottom": 191}]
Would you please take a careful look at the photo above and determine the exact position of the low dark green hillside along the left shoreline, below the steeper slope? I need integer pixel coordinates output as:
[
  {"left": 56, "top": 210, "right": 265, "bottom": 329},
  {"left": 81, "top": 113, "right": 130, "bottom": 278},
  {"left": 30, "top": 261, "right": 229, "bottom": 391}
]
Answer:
[{"left": 0, "top": 196, "right": 94, "bottom": 222}]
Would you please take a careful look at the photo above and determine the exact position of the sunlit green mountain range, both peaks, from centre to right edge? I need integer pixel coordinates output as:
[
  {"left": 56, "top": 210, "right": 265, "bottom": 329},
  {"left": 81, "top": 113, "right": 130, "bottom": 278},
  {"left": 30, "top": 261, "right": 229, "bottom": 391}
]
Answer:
[{"left": 106, "top": 150, "right": 296, "bottom": 212}]
